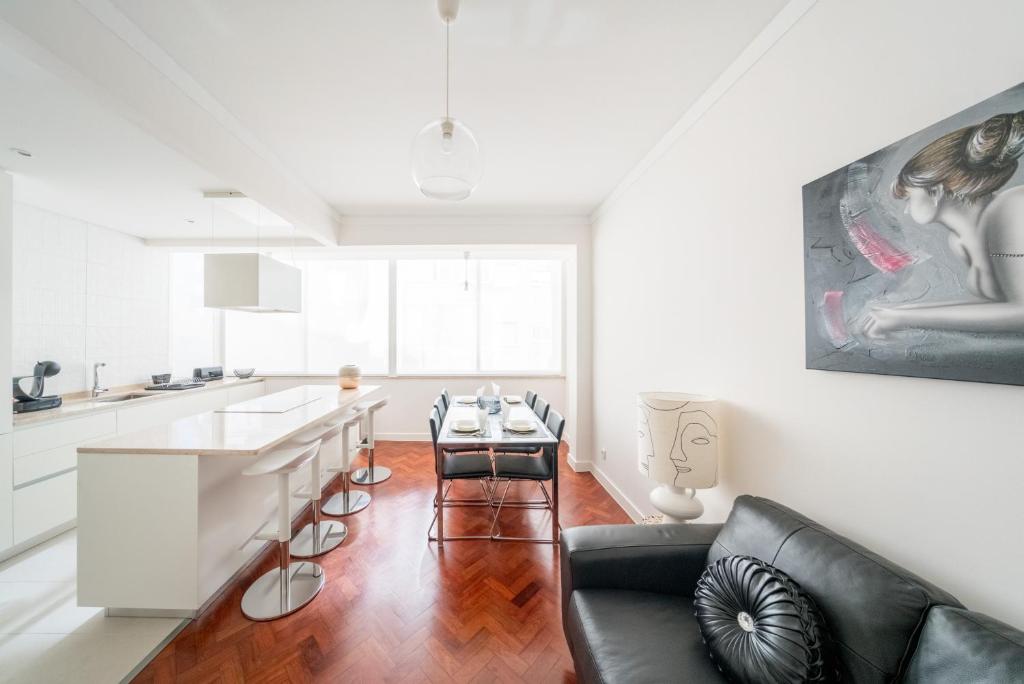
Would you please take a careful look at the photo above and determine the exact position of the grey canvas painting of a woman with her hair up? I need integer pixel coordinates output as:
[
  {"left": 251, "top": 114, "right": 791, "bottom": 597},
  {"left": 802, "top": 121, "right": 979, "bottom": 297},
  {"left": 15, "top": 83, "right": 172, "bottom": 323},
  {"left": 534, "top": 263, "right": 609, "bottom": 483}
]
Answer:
[{"left": 804, "top": 84, "right": 1024, "bottom": 385}]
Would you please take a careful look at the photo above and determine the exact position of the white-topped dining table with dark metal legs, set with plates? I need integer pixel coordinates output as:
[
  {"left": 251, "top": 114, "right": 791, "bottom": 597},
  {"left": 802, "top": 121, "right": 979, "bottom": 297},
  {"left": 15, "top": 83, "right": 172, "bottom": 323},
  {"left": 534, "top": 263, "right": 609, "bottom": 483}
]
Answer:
[{"left": 434, "top": 397, "right": 559, "bottom": 547}]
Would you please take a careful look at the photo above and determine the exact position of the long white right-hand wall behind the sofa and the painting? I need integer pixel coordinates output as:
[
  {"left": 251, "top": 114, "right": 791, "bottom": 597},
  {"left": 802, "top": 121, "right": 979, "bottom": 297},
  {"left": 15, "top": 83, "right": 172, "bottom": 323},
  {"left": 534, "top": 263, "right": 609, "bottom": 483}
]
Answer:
[{"left": 593, "top": 0, "right": 1024, "bottom": 626}]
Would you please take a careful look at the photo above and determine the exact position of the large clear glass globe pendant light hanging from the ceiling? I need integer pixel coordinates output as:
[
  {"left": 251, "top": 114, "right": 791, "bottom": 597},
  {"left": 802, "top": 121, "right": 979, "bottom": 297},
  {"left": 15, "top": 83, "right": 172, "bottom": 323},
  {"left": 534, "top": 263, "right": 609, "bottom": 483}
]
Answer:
[{"left": 413, "top": 0, "right": 483, "bottom": 202}]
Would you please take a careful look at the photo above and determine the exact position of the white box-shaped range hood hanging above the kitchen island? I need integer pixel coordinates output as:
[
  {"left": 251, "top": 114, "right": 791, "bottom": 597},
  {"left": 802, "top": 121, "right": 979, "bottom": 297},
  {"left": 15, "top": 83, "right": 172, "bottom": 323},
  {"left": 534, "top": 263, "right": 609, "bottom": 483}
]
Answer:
[{"left": 203, "top": 253, "right": 302, "bottom": 313}]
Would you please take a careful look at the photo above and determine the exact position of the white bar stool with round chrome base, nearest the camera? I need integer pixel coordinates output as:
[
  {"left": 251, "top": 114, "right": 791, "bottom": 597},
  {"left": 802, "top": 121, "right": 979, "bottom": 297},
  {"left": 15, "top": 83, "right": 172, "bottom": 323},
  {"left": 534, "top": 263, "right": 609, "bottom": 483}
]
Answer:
[{"left": 242, "top": 440, "right": 325, "bottom": 622}]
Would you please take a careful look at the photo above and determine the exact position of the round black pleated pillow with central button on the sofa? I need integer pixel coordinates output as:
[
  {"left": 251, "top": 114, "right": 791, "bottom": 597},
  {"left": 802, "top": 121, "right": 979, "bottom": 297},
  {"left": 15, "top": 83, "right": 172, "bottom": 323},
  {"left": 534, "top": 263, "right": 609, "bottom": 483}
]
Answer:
[{"left": 693, "top": 556, "right": 838, "bottom": 684}]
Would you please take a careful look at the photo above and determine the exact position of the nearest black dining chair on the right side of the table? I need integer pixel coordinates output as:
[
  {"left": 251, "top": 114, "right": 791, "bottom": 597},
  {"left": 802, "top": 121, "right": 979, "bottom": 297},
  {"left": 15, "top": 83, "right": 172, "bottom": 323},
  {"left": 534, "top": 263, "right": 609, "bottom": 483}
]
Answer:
[{"left": 490, "top": 410, "right": 565, "bottom": 544}]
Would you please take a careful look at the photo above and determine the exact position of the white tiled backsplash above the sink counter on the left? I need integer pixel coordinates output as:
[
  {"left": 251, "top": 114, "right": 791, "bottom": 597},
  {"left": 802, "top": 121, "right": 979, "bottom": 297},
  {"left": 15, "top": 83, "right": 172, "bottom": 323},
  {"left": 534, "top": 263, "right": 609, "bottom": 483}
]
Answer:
[{"left": 13, "top": 204, "right": 169, "bottom": 394}]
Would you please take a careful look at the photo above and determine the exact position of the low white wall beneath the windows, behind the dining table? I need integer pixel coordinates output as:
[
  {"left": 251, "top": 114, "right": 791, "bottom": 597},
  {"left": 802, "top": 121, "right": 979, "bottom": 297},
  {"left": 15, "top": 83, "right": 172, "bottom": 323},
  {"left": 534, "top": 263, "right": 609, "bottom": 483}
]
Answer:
[{"left": 260, "top": 376, "right": 570, "bottom": 441}]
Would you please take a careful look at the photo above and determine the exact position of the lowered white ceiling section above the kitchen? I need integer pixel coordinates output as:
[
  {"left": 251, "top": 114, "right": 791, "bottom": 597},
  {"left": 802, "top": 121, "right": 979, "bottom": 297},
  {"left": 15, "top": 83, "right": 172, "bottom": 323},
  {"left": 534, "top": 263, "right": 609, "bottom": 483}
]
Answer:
[{"left": 0, "top": 44, "right": 281, "bottom": 240}]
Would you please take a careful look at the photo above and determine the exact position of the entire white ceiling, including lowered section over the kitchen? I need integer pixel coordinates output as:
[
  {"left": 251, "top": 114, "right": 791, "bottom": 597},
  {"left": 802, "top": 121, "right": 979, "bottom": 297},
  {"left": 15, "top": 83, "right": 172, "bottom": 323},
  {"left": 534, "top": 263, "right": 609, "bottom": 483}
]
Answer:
[{"left": 0, "top": 0, "right": 784, "bottom": 238}]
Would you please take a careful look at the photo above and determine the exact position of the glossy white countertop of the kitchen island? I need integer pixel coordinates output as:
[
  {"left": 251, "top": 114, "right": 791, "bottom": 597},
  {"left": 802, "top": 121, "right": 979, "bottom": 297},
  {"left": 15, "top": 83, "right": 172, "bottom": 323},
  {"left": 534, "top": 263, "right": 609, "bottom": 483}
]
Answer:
[{"left": 78, "top": 385, "right": 380, "bottom": 456}]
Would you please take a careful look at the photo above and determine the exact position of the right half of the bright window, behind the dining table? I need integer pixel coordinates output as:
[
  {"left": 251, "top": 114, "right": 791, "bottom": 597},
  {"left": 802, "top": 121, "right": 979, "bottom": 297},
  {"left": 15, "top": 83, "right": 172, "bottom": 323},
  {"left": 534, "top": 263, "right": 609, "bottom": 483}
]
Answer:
[{"left": 396, "top": 259, "right": 562, "bottom": 374}]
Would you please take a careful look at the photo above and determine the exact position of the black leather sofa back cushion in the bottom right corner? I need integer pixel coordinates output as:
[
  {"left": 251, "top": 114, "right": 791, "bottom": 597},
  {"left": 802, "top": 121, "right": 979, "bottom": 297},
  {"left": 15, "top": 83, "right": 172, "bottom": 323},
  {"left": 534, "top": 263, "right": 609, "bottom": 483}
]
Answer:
[{"left": 904, "top": 606, "right": 1024, "bottom": 684}]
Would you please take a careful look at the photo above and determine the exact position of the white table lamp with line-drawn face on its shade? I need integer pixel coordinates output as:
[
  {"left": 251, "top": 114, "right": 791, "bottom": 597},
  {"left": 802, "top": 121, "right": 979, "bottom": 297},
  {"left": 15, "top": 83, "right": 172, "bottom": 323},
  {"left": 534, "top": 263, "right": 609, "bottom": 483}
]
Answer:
[{"left": 637, "top": 392, "right": 720, "bottom": 522}]
